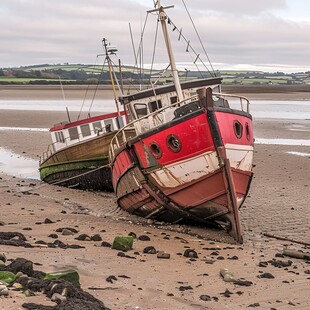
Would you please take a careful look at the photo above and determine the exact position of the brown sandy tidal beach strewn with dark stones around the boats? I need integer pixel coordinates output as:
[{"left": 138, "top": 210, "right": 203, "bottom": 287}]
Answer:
[{"left": 0, "top": 86, "right": 310, "bottom": 310}]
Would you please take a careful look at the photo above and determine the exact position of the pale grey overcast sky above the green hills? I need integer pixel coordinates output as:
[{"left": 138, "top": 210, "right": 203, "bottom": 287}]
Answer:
[{"left": 0, "top": 0, "right": 310, "bottom": 71}]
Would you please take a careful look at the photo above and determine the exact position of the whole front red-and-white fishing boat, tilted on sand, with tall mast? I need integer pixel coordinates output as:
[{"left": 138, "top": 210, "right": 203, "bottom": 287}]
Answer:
[{"left": 109, "top": 1, "right": 254, "bottom": 243}]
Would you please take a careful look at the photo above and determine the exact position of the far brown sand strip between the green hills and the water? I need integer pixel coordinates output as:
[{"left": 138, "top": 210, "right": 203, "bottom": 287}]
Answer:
[{"left": 0, "top": 84, "right": 310, "bottom": 100}]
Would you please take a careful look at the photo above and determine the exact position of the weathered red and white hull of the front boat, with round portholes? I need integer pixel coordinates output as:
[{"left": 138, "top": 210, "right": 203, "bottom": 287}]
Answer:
[{"left": 112, "top": 109, "right": 253, "bottom": 241}]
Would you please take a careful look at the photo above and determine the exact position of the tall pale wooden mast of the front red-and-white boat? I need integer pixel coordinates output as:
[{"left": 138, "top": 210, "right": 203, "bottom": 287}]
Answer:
[{"left": 156, "top": 0, "right": 184, "bottom": 101}]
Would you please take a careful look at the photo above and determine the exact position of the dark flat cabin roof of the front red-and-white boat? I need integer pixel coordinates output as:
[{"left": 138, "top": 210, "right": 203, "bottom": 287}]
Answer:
[{"left": 119, "top": 77, "right": 222, "bottom": 104}]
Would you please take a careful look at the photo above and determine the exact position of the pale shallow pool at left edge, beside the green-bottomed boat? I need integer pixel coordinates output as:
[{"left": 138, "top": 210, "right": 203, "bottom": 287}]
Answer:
[{"left": 0, "top": 147, "right": 40, "bottom": 179}]
